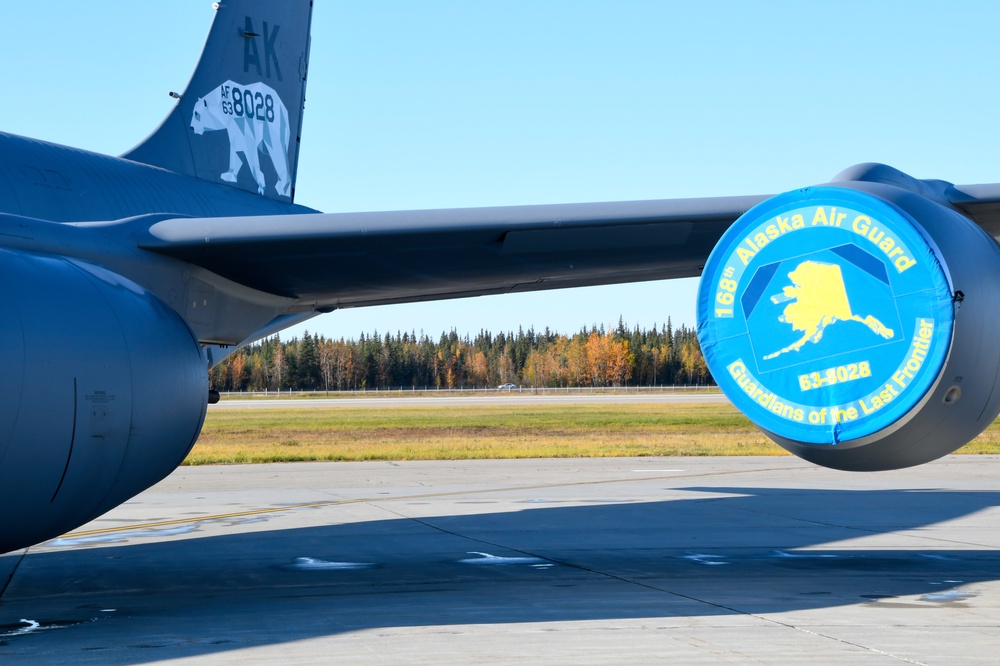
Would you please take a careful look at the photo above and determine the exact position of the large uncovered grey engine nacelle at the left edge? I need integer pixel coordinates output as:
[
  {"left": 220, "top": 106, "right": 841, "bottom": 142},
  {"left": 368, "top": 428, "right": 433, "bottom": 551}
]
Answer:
[{"left": 0, "top": 250, "right": 208, "bottom": 552}]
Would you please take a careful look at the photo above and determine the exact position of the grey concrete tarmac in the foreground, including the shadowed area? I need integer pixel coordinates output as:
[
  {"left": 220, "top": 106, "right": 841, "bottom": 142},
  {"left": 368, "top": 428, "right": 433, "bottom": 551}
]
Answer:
[{"left": 0, "top": 456, "right": 1000, "bottom": 665}]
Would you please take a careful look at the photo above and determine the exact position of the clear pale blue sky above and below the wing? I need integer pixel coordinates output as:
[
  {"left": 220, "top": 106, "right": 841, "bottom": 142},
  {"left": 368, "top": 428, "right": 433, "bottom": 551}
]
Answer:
[{"left": 0, "top": 0, "right": 1000, "bottom": 337}]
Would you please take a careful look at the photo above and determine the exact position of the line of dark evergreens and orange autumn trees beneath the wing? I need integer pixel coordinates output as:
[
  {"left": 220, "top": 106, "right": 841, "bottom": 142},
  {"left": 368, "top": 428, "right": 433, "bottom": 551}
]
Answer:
[{"left": 210, "top": 319, "right": 714, "bottom": 391}]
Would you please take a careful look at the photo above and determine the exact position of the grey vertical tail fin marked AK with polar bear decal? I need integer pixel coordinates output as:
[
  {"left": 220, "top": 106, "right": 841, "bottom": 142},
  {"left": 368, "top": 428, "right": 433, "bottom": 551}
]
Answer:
[{"left": 122, "top": 0, "right": 312, "bottom": 201}]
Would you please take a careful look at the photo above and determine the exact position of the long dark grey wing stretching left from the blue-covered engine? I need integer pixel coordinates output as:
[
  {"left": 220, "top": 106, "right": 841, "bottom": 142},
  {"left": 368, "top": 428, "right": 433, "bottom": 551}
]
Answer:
[{"left": 139, "top": 196, "right": 766, "bottom": 310}]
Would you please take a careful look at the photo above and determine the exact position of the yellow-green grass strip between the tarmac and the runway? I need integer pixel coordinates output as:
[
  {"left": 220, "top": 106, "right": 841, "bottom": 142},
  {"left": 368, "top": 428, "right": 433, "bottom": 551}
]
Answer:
[{"left": 184, "top": 404, "right": 1000, "bottom": 465}]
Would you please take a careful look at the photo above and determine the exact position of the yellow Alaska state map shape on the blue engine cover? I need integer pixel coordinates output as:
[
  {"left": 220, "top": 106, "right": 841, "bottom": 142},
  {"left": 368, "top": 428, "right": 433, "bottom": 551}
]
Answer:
[{"left": 764, "top": 261, "right": 893, "bottom": 361}]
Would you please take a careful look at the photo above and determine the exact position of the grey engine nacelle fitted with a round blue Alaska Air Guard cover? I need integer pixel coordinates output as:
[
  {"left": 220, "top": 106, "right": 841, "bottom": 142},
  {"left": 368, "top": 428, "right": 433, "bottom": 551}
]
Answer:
[{"left": 698, "top": 182, "right": 1000, "bottom": 470}]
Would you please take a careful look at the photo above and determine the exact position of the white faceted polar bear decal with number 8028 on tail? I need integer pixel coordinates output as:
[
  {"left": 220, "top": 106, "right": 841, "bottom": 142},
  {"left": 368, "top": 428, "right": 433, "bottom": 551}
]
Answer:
[{"left": 191, "top": 81, "right": 292, "bottom": 197}]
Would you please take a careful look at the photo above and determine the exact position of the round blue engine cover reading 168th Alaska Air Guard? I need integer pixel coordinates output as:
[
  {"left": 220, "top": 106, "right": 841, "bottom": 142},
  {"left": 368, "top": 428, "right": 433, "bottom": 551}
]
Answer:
[{"left": 698, "top": 187, "right": 954, "bottom": 444}]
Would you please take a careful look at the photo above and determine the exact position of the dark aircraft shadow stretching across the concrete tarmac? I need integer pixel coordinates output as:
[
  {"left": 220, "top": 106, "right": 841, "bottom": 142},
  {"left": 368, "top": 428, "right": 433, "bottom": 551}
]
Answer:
[{"left": 0, "top": 487, "right": 1000, "bottom": 663}]
